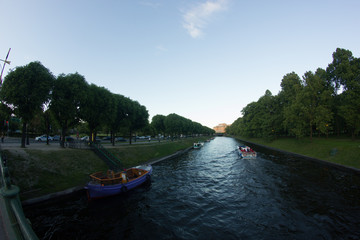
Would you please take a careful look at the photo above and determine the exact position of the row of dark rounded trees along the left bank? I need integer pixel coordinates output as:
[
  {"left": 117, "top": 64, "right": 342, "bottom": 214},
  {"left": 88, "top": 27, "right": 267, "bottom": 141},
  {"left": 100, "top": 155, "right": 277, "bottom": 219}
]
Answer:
[{"left": 0, "top": 62, "right": 213, "bottom": 147}]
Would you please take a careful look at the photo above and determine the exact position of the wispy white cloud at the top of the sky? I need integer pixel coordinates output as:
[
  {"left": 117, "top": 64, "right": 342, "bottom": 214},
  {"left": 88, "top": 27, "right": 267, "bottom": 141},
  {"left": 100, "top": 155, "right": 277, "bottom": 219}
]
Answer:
[{"left": 183, "top": 0, "right": 228, "bottom": 38}]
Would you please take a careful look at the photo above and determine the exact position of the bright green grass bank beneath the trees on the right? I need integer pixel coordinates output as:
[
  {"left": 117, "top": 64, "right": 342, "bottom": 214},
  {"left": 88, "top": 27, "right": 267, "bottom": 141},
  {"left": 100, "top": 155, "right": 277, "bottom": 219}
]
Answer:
[{"left": 237, "top": 137, "right": 360, "bottom": 169}]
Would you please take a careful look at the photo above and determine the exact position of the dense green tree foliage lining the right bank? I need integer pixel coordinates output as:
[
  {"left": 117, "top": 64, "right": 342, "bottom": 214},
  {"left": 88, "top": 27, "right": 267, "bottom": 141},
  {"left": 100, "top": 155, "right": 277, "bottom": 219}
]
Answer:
[{"left": 226, "top": 48, "right": 360, "bottom": 140}]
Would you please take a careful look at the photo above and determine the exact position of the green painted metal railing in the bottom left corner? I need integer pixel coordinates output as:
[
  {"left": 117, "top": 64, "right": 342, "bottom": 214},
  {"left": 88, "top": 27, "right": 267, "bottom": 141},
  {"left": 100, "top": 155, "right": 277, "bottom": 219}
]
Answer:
[{"left": 0, "top": 155, "right": 39, "bottom": 240}]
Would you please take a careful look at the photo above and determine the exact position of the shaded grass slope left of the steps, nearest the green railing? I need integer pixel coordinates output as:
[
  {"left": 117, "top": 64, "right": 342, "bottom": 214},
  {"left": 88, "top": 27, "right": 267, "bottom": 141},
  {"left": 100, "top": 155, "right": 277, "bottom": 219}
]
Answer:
[{"left": 5, "top": 149, "right": 107, "bottom": 200}]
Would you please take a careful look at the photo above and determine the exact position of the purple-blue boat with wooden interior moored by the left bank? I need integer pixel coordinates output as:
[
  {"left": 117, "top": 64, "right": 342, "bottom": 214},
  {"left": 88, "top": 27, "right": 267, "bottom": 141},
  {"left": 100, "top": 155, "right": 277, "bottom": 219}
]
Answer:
[{"left": 85, "top": 165, "right": 152, "bottom": 199}]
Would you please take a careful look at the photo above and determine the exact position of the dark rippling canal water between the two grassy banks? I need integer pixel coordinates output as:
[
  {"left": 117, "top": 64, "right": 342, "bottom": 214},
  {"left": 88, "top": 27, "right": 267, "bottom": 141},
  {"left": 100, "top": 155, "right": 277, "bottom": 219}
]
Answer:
[{"left": 25, "top": 137, "right": 360, "bottom": 240}]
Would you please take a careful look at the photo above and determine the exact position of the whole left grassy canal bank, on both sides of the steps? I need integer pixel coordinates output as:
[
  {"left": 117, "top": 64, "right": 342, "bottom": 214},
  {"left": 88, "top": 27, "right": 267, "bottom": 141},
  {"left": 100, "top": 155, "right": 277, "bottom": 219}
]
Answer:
[{"left": 4, "top": 139, "right": 208, "bottom": 200}]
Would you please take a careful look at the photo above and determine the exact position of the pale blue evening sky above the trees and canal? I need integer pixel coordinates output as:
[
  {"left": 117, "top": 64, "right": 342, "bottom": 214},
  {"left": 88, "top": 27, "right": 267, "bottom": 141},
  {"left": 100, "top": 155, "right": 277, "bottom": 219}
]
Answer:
[{"left": 0, "top": 0, "right": 360, "bottom": 128}]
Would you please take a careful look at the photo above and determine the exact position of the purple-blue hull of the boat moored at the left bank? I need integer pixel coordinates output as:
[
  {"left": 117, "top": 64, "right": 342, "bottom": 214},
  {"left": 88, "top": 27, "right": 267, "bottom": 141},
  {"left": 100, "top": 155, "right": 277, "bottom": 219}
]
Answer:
[{"left": 85, "top": 165, "right": 152, "bottom": 199}]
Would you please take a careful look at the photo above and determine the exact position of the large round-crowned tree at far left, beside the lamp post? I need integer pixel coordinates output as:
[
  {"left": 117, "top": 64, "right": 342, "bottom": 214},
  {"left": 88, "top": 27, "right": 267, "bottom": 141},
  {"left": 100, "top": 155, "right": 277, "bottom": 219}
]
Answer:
[{"left": 0, "top": 62, "right": 54, "bottom": 148}]
